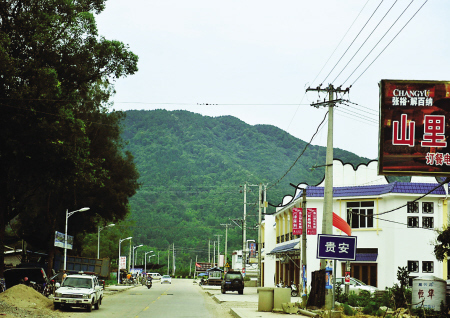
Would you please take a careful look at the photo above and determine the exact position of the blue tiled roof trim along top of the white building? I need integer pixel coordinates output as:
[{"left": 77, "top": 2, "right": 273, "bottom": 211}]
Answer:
[{"left": 295, "top": 181, "right": 445, "bottom": 199}]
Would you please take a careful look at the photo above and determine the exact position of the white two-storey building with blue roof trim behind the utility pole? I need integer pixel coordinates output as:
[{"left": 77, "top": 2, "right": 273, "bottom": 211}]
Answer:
[{"left": 262, "top": 160, "right": 448, "bottom": 289}]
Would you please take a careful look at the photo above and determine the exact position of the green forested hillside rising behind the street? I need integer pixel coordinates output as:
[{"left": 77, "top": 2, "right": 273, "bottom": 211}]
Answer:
[{"left": 118, "top": 110, "right": 368, "bottom": 271}]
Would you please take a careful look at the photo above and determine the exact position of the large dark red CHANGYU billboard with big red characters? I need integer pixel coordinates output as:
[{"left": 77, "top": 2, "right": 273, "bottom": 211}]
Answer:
[{"left": 378, "top": 80, "right": 450, "bottom": 176}]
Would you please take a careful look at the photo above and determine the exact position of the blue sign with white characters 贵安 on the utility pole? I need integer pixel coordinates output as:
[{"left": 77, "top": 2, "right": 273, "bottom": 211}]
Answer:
[{"left": 317, "top": 234, "right": 356, "bottom": 261}]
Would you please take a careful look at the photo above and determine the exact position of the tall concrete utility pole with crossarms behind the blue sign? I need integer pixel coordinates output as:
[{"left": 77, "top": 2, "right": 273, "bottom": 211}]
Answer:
[{"left": 306, "top": 84, "right": 349, "bottom": 309}]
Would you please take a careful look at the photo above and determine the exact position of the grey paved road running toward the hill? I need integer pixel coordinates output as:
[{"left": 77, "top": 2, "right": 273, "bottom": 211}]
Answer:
[{"left": 62, "top": 279, "right": 232, "bottom": 318}]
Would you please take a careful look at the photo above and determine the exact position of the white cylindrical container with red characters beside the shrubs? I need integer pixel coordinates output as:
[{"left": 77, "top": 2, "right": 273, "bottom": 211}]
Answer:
[{"left": 412, "top": 275, "right": 447, "bottom": 311}]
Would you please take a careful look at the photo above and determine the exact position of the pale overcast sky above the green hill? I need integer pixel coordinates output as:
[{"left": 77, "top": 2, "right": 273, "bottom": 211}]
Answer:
[{"left": 96, "top": 0, "right": 450, "bottom": 159}]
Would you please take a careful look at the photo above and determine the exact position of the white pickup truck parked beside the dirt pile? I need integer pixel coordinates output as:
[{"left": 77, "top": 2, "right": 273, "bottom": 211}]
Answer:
[{"left": 53, "top": 274, "right": 103, "bottom": 311}]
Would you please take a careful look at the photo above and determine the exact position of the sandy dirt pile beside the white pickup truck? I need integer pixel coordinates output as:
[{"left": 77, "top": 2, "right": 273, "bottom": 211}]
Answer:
[{"left": 0, "top": 284, "right": 61, "bottom": 318}]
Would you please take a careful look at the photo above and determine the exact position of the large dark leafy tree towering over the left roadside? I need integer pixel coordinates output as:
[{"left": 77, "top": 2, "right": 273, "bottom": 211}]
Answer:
[{"left": 0, "top": 0, "right": 138, "bottom": 270}]
